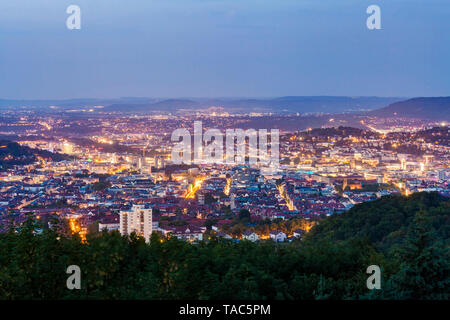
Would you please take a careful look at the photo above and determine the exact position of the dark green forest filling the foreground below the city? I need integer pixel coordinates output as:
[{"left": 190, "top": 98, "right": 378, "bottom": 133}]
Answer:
[{"left": 0, "top": 193, "right": 450, "bottom": 299}]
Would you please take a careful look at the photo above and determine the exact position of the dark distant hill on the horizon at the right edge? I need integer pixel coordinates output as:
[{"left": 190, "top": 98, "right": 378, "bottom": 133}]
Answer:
[{"left": 368, "top": 97, "right": 450, "bottom": 121}]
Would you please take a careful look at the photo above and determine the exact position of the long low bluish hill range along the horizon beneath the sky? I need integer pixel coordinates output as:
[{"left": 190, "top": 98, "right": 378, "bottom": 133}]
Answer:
[{"left": 0, "top": 96, "right": 402, "bottom": 113}]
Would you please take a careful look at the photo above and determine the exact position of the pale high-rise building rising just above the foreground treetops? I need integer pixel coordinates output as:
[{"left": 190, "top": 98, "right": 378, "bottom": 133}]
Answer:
[{"left": 120, "top": 205, "right": 153, "bottom": 242}]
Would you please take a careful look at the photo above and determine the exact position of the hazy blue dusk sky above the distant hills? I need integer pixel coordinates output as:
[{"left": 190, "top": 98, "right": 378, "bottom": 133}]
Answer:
[{"left": 0, "top": 0, "right": 450, "bottom": 99}]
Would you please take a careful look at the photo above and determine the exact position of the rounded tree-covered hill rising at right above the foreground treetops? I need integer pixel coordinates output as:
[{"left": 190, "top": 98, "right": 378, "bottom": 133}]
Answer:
[{"left": 306, "top": 192, "right": 450, "bottom": 250}]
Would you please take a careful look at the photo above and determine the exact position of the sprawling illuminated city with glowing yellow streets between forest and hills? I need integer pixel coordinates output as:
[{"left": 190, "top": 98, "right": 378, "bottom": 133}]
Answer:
[{"left": 0, "top": 109, "right": 450, "bottom": 241}]
